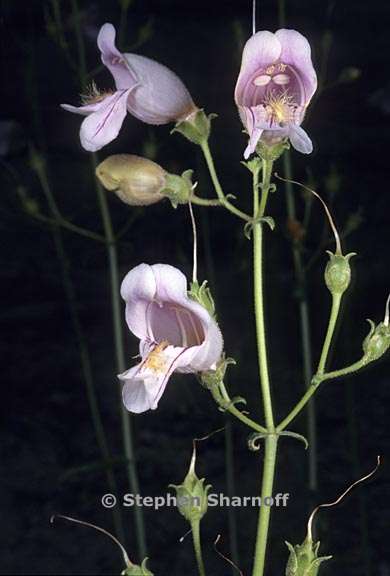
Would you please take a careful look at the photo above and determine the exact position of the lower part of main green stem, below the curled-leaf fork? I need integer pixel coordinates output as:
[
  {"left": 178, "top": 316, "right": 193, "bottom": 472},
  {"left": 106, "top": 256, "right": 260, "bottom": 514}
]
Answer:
[{"left": 252, "top": 434, "right": 278, "bottom": 576}]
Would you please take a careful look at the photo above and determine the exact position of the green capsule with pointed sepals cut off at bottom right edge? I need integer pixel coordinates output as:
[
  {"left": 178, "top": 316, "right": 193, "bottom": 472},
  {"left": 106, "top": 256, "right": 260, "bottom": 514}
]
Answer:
[{"left": 286, "top": 536, "right": 332, "bottom": 576}]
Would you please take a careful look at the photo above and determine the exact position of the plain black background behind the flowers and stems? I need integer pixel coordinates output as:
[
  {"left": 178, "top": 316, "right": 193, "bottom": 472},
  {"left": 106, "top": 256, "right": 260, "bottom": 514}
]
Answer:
[{"left": 0, "top": 0, "right": 390, "bottom": 576}]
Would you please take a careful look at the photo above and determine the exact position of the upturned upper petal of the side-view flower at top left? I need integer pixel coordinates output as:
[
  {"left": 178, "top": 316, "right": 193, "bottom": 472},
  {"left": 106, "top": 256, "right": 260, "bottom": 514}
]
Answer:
[{"left": 97, "top": 23, "right": 137, "bottom": 90}]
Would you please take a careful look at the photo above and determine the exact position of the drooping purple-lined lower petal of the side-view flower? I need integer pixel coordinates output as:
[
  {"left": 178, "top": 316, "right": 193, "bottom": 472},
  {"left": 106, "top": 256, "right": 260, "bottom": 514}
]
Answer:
[{"left": 80, "top": 90, "right": 130, "bottom": 152}]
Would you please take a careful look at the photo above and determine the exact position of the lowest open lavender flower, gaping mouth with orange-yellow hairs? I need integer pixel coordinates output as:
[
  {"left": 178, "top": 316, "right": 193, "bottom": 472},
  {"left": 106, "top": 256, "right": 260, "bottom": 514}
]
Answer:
[{"left": 119, "top": 264, "right": 223, "bottom": 413}]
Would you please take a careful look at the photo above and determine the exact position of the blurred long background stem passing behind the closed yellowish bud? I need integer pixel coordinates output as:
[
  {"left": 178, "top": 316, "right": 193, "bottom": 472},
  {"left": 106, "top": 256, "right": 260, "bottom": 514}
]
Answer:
[{"left": 71, "top": 0, "right": 146, "bottom": 558}]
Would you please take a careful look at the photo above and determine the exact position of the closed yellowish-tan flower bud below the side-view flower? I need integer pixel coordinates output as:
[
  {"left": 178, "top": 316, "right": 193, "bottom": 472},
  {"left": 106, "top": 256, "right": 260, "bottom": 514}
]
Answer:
[{"left": 96, "top": 154, "right": 167, "bottom": 206}]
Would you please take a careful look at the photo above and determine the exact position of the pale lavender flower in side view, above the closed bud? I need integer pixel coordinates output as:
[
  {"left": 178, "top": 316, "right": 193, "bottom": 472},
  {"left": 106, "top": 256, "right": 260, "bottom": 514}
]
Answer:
[{"left": 61, "top": 23, "right": 197, "bottom": 152}]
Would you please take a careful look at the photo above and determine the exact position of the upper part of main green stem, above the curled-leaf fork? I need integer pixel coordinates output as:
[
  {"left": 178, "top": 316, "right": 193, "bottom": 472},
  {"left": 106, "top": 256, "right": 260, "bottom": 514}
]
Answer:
[{"left": 253, "top": 160, "right": 275, "bottom": 432}]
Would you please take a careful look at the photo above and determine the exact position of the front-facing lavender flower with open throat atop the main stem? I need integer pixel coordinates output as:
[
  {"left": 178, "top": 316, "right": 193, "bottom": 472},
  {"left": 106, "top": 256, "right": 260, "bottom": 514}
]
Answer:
[{"left": 234, "top": 29, "right": 317, "bottom": 158}]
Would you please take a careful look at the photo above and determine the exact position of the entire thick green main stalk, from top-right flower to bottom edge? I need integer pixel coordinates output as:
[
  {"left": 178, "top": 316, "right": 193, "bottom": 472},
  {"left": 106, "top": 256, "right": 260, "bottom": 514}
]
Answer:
[{"left": 253, "top": 159, "right": 278, "bottom": 576}]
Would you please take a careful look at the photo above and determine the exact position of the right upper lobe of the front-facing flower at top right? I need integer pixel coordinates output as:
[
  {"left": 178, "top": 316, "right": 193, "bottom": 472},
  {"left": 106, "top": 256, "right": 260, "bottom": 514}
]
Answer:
[{"left": 275, "top": 29, "right": 317, "bottom": 104}]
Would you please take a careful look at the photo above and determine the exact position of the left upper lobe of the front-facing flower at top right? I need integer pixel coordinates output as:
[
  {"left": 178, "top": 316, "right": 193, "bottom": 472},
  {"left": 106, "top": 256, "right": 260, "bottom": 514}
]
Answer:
[{"left": 234, "top": 30, "right": 282, "bottom": 106}]
